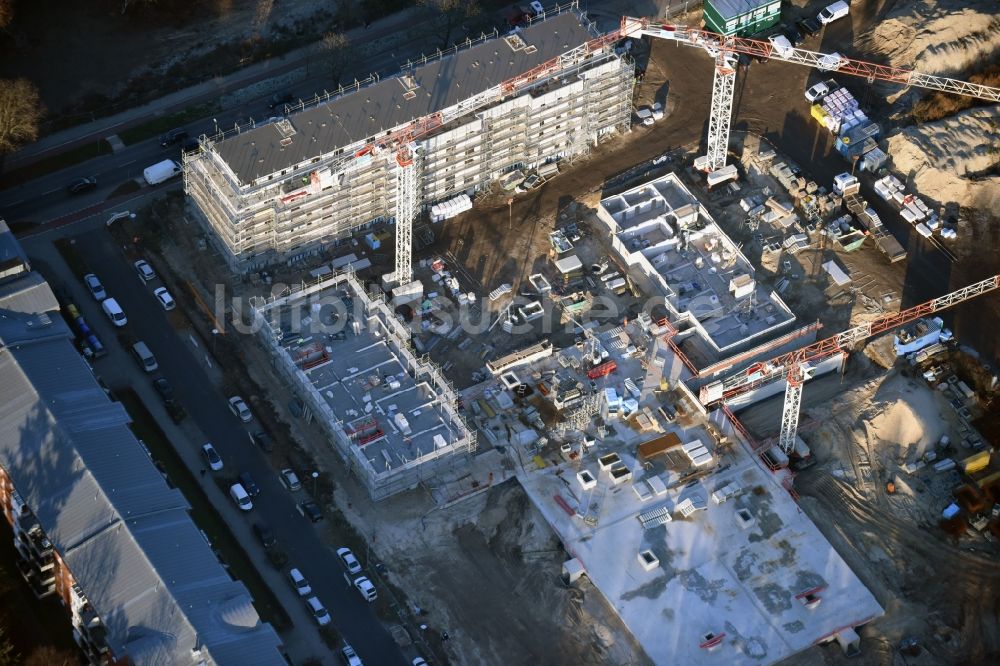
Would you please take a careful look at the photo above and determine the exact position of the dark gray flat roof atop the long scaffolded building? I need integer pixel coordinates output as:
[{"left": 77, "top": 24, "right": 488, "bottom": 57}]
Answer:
[{"left": 215, "top": 12, "right": 593, "bottom": 185}]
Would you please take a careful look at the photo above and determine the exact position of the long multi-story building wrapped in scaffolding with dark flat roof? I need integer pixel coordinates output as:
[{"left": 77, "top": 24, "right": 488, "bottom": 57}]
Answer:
[{"left": 184, "top": 2, "right": 634, "bottom": 271}]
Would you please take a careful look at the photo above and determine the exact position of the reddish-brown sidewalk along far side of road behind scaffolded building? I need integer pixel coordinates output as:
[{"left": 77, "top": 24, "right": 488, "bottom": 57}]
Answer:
[{"left": 4, "top": 8, "right": 420, "bottom": 172}]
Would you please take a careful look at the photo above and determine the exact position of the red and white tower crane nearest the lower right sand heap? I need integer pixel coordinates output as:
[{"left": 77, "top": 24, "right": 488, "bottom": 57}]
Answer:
[{"left": 700, "top": 275, "right": 1000, "bottom": 453}]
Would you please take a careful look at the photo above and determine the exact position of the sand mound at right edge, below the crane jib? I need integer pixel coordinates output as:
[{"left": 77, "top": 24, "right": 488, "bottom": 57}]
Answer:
[{"left": 888, "top": 105, "right": 1000, "bottom": 211}]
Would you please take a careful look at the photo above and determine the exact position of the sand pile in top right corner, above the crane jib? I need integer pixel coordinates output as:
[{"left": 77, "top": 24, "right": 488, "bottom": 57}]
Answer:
[{"left": 859, "top": 0, "right": 1000, "bottom": 75}]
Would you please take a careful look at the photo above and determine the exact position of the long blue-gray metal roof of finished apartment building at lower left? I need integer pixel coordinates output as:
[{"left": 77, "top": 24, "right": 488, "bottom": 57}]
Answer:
[{"left": 0, "top": 272, "right": 284, "bottom": 666}]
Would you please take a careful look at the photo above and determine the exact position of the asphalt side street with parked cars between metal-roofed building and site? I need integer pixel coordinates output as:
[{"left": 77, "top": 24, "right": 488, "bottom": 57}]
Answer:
[{"left": 75, "top": 230, "right": 406, "bottom": 664}]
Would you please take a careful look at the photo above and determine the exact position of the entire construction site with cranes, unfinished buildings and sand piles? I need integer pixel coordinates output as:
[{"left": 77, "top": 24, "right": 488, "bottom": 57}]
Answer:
[{"left": 125, "top": 2, "right": 1000, "bottom": 664}]
